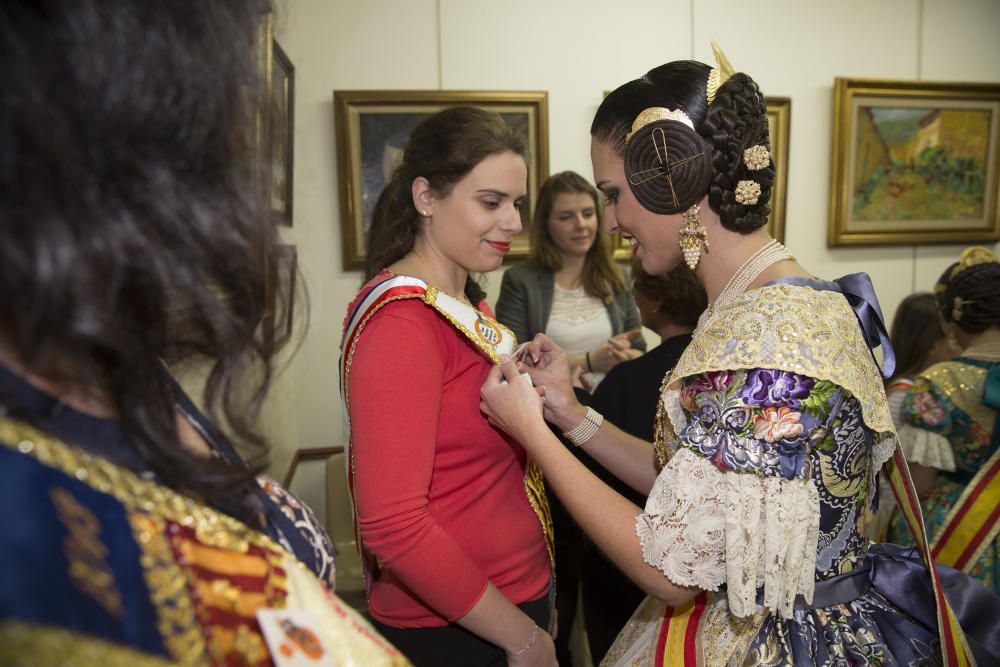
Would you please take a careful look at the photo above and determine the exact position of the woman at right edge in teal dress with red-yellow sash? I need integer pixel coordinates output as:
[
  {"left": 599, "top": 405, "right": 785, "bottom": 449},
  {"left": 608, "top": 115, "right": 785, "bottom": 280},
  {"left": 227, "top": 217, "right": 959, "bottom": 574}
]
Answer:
[{"left": 889, "top": 247, "right": 1000, "bottom": 594}]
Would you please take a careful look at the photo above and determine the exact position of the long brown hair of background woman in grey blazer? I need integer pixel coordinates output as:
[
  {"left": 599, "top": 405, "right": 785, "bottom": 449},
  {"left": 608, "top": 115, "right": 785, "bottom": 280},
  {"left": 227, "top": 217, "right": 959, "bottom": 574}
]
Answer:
[{"left": 530, "top": 171, "right": 625, "bottom": 301}]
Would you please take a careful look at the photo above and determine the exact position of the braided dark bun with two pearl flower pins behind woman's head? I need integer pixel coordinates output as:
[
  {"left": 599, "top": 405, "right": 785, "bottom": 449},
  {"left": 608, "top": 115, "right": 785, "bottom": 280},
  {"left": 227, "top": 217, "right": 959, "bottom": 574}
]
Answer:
[{"left": 698, "top": 72, "right": 775, "bottom": 234}]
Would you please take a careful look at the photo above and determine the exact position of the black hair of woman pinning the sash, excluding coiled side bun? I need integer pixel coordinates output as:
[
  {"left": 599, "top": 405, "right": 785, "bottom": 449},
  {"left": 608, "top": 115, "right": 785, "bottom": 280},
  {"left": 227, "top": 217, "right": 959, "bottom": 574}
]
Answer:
[{"left": 590, "top": 60, "right": 775, "bottom": 233}]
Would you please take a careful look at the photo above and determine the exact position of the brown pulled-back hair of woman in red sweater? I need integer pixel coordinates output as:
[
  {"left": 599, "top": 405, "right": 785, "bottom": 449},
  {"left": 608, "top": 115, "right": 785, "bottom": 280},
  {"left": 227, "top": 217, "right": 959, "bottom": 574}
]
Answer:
[{"left": 364, "top": 107, "right": 528, "bottom": 303}]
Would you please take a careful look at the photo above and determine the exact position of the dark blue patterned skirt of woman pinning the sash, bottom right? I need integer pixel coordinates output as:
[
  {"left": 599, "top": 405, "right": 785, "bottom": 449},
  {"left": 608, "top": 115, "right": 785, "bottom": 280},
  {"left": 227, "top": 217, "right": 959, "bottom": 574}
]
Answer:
[{"left": 601, "top": 544, "right": 1000, "bottom": 667}]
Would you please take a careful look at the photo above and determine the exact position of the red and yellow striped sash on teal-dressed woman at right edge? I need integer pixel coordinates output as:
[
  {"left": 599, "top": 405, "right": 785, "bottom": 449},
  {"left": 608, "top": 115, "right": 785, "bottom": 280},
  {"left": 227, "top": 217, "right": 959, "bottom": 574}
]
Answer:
[{"left": 931, "top": 449, "right": 1000, "bottom": 572}]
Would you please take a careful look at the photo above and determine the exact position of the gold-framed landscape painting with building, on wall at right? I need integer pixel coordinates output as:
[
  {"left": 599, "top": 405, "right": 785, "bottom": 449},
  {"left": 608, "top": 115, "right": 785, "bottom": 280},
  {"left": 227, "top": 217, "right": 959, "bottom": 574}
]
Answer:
[{"left": 827, "top": 77, "right": 1000, "bottom": 246}]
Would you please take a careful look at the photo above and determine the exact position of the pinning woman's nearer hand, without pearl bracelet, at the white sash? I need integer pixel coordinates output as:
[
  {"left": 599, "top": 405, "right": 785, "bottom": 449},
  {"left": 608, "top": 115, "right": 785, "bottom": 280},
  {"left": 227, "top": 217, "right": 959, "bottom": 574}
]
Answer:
[{"left": 479, "top": 355, "right": 547, "bottom": 449}]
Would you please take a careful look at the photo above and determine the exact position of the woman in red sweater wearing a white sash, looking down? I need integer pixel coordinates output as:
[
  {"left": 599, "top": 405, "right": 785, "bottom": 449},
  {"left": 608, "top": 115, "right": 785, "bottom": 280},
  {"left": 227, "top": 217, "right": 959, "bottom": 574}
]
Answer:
[{"left": 341, "top": 107, "right": 555, "bottom": 666}]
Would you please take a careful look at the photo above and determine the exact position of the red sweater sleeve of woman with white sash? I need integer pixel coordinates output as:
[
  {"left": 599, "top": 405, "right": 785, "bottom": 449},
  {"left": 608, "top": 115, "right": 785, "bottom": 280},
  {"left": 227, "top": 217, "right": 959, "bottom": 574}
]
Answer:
[{"left": 349, "top": 302, "right": 488, "bottom": 620}]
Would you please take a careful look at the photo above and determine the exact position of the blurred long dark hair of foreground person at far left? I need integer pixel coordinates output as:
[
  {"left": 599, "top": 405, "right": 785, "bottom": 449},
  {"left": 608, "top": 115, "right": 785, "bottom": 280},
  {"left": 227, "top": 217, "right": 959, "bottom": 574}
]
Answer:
[{"left": 0, "top": 0, "right": 285, "bottom": 520}]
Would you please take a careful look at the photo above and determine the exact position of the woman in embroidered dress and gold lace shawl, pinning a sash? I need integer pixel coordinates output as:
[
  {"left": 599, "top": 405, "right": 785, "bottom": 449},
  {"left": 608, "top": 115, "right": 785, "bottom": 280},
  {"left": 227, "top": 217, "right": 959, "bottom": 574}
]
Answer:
[{"left": 481, "top": 44, "right": 1000, "bottom": 665}]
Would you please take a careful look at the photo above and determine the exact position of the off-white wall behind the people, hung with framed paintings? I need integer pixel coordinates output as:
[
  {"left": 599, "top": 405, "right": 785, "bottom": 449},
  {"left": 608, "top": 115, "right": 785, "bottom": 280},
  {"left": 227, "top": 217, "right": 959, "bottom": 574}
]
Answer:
[{"left": 267, "top": 0, "right": 1000, "bottom": 476}]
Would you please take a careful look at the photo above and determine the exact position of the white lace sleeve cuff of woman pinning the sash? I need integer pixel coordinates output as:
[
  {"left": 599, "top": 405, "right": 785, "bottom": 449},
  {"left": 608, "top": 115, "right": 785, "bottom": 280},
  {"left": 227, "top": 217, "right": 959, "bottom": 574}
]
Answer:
[{"left": 636, "top": 447, "right": 819, "bottom": 618}]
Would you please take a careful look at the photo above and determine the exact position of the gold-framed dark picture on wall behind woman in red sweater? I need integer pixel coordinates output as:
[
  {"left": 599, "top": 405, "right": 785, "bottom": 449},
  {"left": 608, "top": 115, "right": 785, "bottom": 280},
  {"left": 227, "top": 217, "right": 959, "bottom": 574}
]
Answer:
[{"left": 333, "top": 90, "right": 549, "bottom": 270}]
